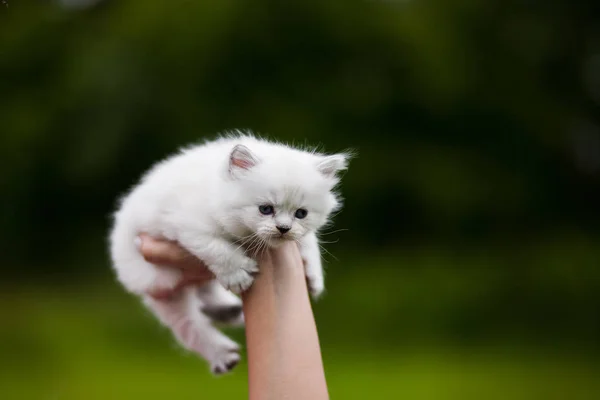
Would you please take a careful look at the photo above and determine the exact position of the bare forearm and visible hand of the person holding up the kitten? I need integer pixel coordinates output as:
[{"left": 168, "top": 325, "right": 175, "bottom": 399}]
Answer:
[{"left": 138, "top": 235, "right": 329, "bottom": 400}]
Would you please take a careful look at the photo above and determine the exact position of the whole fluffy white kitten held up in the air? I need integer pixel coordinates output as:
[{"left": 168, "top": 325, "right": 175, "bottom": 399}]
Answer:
[{"left": 110, "top": 135, "right": 348, "bottom": 374}]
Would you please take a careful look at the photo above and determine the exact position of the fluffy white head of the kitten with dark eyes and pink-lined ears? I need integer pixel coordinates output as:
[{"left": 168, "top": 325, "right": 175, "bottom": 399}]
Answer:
[{"left": 229, "top": 143, "right": 349, "bottom": 247}]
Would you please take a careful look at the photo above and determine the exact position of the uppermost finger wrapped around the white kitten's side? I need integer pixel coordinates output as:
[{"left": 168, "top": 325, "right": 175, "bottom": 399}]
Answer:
[{"left": 139, "top": 233, "right": 206, "bottom": 270}]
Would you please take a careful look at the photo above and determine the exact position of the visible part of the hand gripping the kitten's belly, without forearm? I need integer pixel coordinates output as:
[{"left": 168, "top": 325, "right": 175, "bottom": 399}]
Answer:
[{"left": 136, "top": 233, "right": 215, "bottom": 300}]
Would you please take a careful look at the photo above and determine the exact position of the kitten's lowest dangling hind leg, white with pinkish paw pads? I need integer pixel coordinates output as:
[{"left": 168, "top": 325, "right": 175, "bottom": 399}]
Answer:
[{"left": 144, "top": 288, "right": 240, "bottom": 375}]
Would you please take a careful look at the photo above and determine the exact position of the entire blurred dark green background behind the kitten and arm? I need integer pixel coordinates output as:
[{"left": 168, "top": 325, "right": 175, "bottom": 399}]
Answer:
[{"left": 0, "top": 0, "right": 600, "bottom": 400}]
